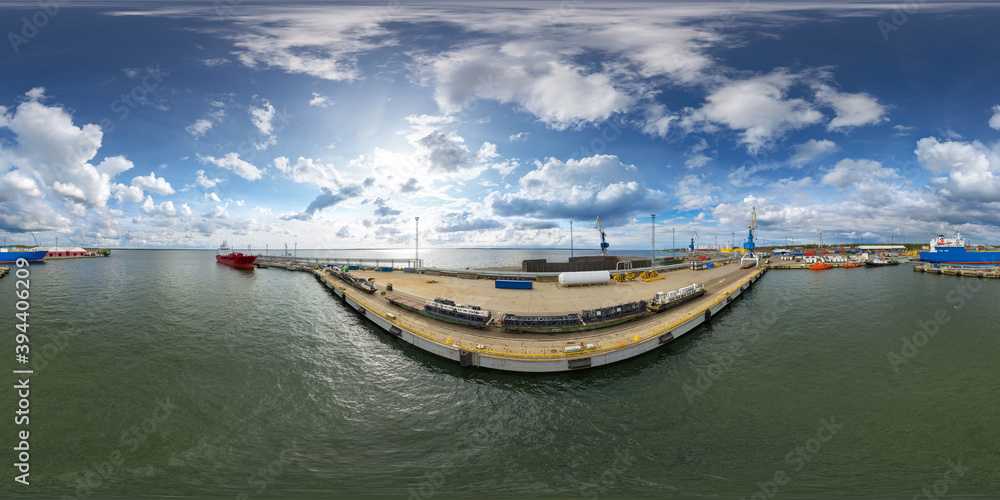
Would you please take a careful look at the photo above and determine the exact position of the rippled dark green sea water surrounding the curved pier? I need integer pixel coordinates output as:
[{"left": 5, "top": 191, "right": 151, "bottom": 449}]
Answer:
[{"left": 0, "top": 250, "right": 1000, "bottom": 499}]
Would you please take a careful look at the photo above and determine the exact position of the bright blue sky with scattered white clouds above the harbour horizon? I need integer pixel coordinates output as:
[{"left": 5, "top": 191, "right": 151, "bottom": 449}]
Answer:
[{"left": 0, "top": 0, "right": 1000, "bottom": 250}]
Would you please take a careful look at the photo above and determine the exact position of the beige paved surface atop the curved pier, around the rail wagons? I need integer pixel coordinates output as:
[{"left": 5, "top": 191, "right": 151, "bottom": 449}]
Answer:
[{"left": 329, "top": 264, "right": 754, "bottom": 358}]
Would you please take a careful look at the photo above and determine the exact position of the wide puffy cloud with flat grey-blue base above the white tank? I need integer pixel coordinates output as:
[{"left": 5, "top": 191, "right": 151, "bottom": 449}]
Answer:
[{"left": 486, "top": 155, "right": 663, "bottom": 220}]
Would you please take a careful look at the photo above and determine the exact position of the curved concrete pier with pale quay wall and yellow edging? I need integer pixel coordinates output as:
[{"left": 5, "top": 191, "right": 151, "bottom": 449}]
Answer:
[{"left": 308, "top": 264, "right": 766, "bottom": 372}]
